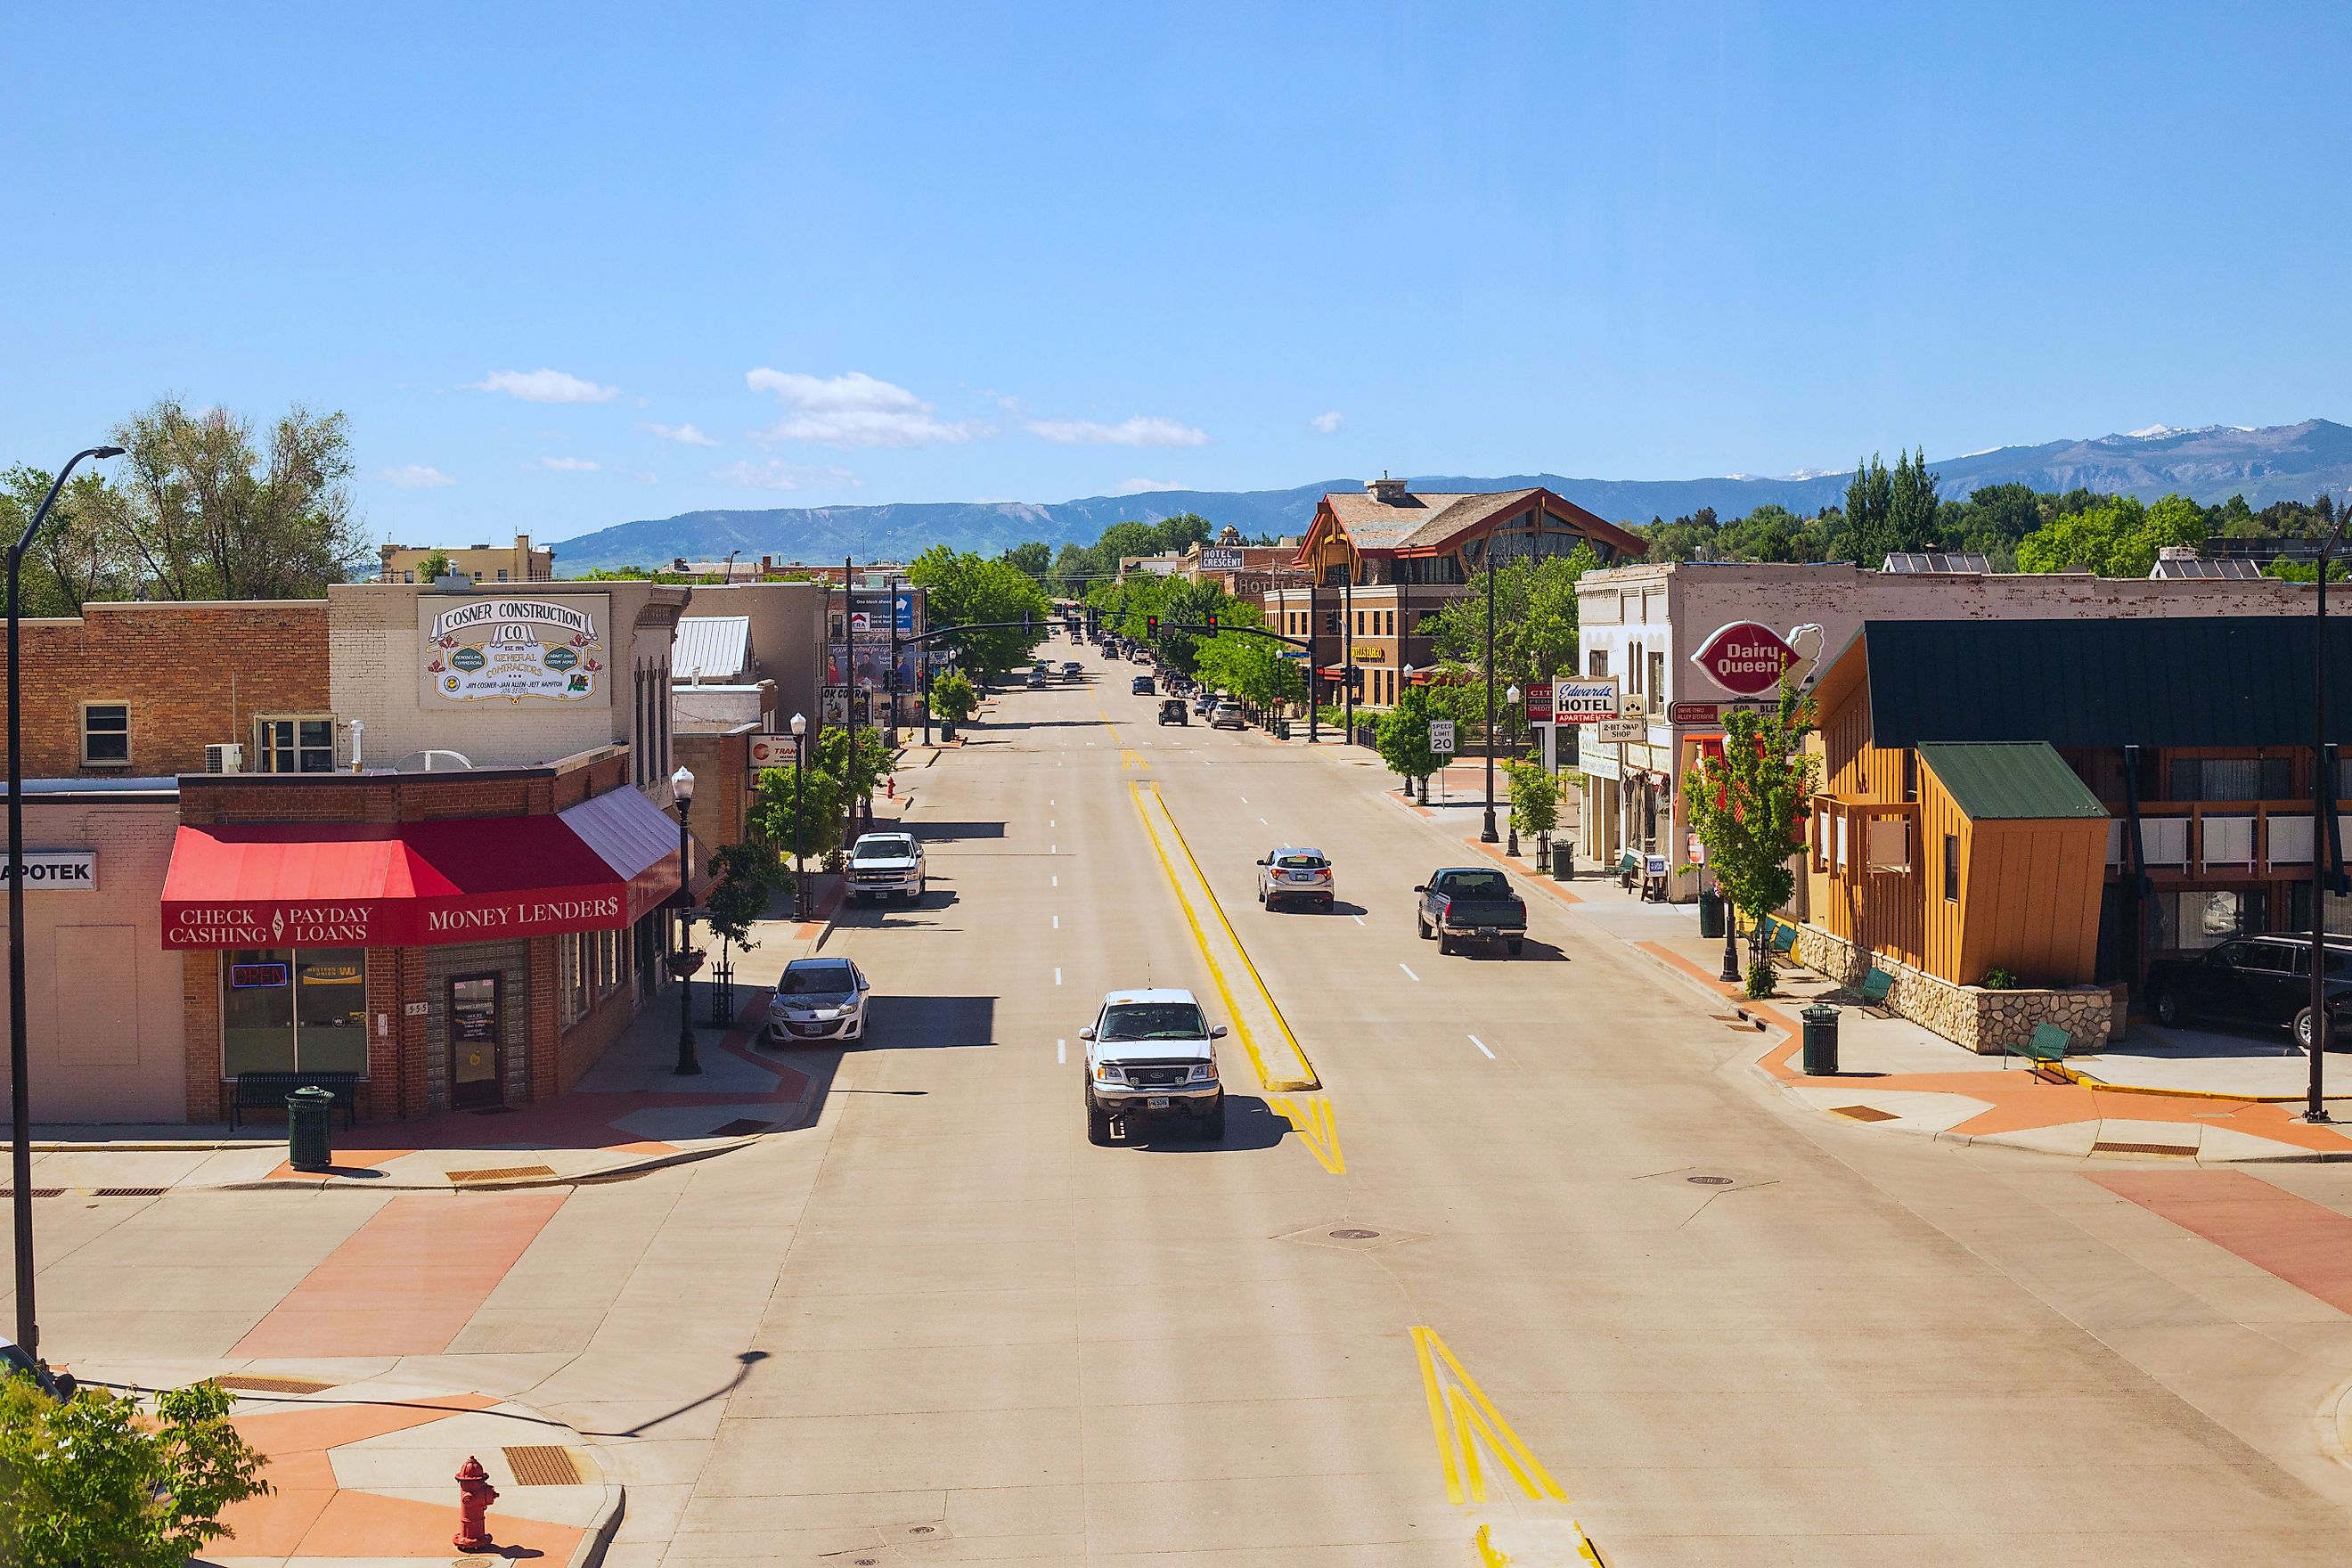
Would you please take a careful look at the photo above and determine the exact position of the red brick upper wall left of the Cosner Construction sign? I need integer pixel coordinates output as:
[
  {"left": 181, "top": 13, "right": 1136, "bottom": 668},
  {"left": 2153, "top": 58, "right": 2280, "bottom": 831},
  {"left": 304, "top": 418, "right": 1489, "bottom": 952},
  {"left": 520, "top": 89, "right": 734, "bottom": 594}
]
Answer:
[{"left": 0, "top": 600, "right": 330, "bottom": 778}]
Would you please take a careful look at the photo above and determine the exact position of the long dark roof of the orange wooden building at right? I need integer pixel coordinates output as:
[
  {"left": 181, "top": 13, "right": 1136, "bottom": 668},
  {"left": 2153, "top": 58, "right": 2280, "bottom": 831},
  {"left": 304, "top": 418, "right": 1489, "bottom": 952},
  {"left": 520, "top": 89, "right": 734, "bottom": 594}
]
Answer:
[{"left": 1860, "top": 616, "right": 2352, "bottom": 745}]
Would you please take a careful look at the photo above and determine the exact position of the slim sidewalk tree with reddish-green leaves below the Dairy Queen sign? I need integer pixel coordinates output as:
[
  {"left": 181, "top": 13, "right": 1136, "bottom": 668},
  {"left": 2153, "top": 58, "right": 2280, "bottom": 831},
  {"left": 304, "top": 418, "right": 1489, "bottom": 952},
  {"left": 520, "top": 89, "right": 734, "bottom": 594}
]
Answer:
[{"left": 1682, "top": 682, "right": 1816, "bottom": 997}]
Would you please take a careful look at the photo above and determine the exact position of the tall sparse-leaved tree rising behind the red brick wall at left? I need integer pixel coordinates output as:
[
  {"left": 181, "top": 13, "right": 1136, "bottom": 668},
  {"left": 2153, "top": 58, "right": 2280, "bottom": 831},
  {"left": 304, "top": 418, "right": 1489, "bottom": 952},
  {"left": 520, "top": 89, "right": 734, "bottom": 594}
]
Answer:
[{"left": 99, "top": 397, "right": 367, "bottom": 600}]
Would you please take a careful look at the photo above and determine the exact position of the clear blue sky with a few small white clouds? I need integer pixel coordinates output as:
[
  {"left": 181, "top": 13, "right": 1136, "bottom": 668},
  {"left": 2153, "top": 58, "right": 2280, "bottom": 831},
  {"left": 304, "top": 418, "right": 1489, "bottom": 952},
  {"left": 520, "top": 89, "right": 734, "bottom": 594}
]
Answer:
[{"left": 0, "top": 0, "right": 2352, "bottom": 543}]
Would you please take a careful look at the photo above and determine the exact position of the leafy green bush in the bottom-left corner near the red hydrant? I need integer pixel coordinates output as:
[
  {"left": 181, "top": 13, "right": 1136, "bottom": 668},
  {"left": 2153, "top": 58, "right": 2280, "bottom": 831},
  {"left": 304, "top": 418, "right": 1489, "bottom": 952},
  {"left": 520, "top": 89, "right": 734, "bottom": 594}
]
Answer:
[{"left": 0, "top": 1376, "right": 271, "bottom": 1568}]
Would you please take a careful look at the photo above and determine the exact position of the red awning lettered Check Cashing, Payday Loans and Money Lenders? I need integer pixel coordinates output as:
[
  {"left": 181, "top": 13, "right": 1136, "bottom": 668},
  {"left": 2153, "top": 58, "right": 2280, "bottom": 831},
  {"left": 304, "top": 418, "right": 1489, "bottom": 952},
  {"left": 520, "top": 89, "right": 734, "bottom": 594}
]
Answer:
[{"left": 162, "top": 790, "right": 677, "bottom": 947}]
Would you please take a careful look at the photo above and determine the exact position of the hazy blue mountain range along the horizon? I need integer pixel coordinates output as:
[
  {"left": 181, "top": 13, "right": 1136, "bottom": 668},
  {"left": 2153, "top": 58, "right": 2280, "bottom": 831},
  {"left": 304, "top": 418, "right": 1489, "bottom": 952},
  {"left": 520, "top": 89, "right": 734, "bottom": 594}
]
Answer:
[{"left": 555, "top": 419, "right": 2352, "bottom": 576}]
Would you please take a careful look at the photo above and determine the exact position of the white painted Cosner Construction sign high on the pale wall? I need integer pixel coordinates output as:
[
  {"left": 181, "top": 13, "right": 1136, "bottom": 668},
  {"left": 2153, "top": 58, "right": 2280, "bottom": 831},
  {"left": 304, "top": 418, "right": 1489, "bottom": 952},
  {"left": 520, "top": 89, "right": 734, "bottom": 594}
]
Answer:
[{"left": 416, "top": 592, "right": 611, "bottom": 707}]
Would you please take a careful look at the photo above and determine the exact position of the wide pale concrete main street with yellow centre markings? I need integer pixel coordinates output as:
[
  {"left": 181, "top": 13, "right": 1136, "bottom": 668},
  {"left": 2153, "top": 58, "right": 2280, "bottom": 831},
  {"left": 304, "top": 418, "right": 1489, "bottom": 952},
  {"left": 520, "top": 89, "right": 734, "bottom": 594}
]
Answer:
[{"left": 22, "top": 647, "right": 2352, "bottom": 1568}]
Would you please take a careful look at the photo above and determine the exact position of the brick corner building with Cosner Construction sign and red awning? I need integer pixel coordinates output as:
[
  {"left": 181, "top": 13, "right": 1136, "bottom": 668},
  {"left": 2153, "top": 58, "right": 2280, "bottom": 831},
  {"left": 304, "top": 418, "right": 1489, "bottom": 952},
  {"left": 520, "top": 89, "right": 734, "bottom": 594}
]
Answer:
[{"left": 0, "top": 583, "right": 687, "bottom": 1123}]
